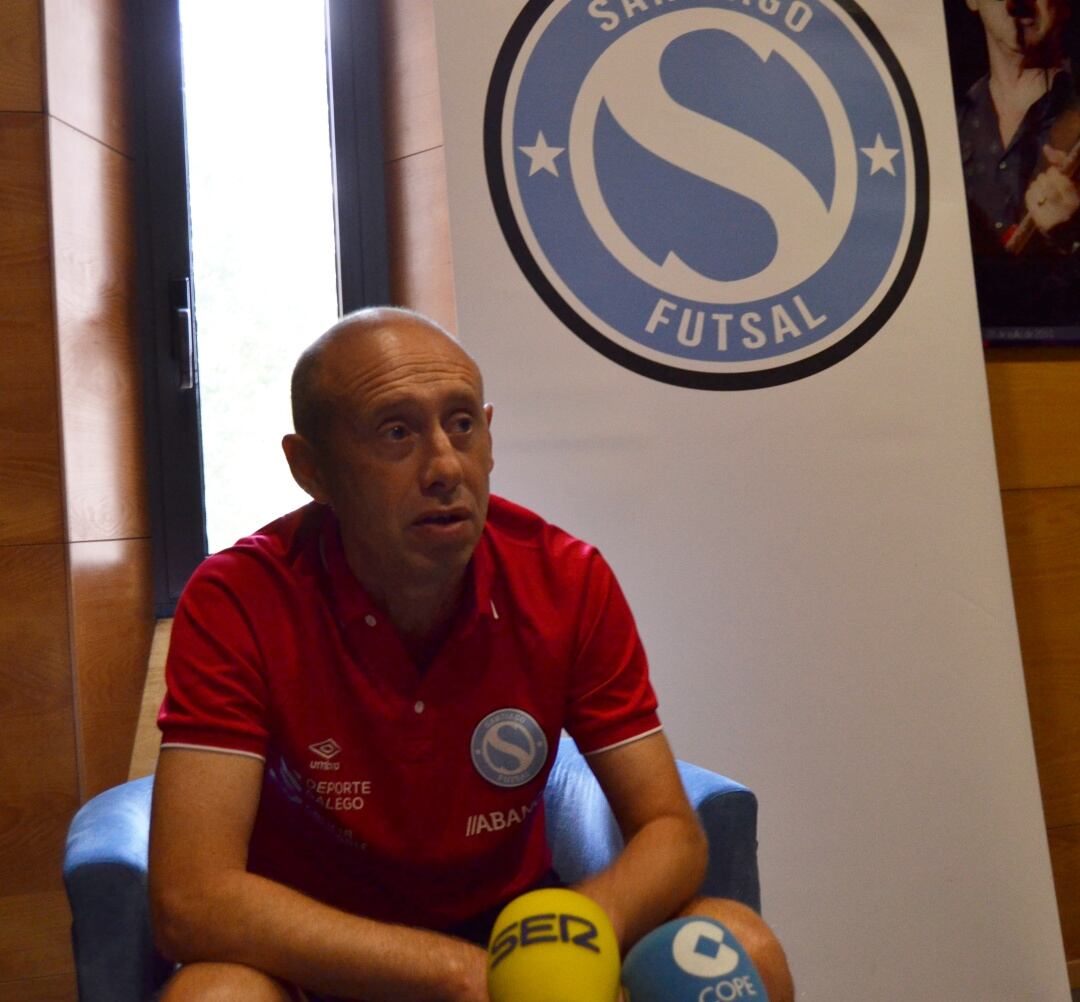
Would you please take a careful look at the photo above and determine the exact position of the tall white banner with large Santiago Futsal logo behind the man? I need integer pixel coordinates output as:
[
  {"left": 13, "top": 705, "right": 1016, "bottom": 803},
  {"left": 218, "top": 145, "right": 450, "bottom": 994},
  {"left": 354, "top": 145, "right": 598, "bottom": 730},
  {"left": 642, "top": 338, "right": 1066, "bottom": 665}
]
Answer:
[{"left": 436, "top": 0, "right": 1068, "bottom": 1002}]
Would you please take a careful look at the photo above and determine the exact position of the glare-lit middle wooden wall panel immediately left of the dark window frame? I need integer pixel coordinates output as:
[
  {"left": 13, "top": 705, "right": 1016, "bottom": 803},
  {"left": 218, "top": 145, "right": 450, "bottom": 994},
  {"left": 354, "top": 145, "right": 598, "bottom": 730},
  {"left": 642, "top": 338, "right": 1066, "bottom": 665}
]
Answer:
[{"left": 49, "top": 121, "right": 149, "bottom": 541}]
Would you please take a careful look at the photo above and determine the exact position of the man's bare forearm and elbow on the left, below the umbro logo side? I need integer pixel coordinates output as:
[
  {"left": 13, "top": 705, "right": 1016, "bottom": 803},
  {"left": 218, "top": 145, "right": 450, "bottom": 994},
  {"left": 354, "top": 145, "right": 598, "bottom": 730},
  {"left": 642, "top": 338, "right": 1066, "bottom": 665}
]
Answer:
[{"left": 150, "top": 748, "right": 487, "bottom": 1002}]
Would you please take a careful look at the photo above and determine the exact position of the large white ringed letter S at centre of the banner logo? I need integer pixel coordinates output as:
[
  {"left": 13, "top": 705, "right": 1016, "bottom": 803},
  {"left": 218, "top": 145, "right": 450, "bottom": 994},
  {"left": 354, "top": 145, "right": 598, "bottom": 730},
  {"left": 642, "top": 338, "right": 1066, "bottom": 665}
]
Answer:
[{"left": 569, "top": 8, "right": 859, "bottom": 304}]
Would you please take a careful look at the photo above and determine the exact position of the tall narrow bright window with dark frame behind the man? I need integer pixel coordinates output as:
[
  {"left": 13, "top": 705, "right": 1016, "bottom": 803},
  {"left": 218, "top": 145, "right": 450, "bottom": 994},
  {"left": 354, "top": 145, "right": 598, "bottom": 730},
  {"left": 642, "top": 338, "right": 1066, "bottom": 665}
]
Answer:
[{"left": 132, "top": 0, "right": 389, "bottom": 615}]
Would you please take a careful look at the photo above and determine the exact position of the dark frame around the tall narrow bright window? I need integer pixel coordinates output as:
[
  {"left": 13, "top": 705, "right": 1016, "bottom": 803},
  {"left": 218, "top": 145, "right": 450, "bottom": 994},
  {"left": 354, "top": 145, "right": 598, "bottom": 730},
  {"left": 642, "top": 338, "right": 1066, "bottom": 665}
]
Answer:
[{"left": 126, "top": 0, "right": 390, "bottom": 617}]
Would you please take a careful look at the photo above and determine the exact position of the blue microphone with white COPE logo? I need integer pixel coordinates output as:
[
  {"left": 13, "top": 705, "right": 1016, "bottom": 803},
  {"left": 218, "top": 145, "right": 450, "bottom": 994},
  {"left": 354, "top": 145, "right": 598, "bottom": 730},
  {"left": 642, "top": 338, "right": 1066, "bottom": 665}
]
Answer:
[{"left": 622, "top": 916, "right": 769, "bottom": 1002}]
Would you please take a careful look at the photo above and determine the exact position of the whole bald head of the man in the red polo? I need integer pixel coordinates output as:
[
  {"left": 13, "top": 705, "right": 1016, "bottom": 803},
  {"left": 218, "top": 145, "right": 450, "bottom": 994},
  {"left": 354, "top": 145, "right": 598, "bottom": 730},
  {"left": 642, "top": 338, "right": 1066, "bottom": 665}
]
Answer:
[{"left": 281, "top": 308, "right": 494, "bottom": 604}]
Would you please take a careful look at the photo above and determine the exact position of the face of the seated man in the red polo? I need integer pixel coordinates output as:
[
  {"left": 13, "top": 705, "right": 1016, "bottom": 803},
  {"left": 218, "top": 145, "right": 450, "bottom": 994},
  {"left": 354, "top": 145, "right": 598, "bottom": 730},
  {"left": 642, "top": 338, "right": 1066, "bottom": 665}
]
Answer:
[{"left": 311, "top": 319, "right": 492, "bottom": 596}]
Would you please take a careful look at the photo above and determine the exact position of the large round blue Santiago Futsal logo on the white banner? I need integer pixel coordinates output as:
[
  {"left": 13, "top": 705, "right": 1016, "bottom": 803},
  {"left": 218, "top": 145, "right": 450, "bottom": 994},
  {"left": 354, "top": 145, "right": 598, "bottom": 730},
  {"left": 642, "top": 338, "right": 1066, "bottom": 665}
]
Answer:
[{"left": 485, "top": 0, "right": 929, "bottom": 390}]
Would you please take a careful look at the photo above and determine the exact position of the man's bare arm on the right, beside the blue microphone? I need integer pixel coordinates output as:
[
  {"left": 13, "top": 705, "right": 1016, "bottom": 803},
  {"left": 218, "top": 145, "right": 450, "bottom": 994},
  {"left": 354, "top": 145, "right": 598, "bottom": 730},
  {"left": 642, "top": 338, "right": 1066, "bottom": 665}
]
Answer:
[{"left": 577, "top": 732, "right": 708, "bottom": 950}]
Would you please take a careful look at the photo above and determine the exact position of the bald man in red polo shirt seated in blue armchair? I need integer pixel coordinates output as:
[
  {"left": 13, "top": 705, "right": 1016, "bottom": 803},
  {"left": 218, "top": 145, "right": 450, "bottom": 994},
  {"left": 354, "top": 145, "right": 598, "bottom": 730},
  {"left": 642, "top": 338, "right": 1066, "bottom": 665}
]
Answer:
[{"left": 150, "top": 309, "right": 791, "bottom": 1002}]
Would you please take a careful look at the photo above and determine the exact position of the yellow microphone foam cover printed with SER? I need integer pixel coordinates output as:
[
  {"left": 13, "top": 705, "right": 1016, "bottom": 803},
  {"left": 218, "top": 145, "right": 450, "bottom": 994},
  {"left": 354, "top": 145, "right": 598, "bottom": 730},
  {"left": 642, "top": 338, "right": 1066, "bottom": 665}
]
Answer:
[{"left": 487, "top": 888, "right": 619, "bottom": 1002}]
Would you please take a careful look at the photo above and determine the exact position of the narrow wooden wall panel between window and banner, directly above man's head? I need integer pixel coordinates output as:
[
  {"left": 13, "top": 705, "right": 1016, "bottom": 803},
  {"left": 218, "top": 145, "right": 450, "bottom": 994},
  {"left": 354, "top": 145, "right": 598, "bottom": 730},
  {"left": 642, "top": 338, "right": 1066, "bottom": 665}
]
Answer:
[{"left": 386, "top": 147, "right": 457, "bottom": 330}]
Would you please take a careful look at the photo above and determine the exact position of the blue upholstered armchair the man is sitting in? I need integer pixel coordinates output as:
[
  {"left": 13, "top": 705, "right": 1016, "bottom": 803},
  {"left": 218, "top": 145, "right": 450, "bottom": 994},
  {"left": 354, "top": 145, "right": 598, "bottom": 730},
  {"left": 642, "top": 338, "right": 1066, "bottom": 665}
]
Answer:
[{"left": 64, "top": 737, "right": 760, "bottom": 1002}]
